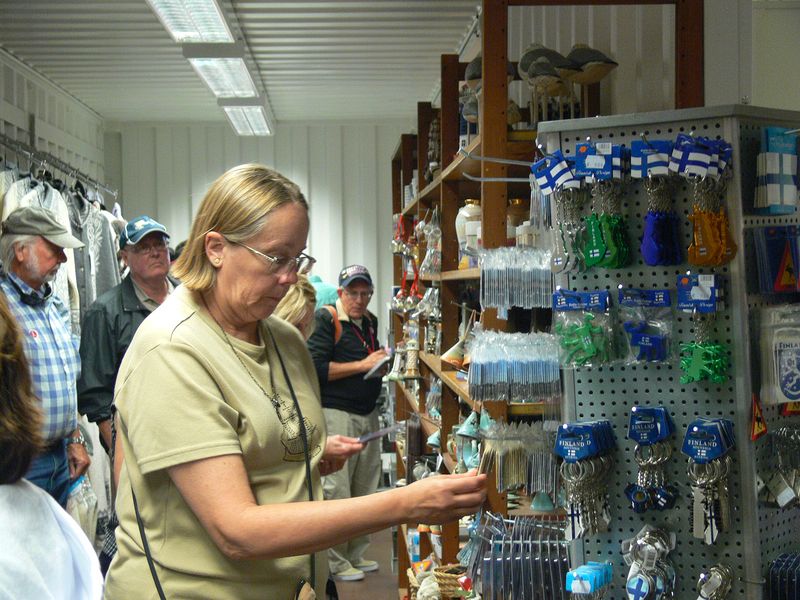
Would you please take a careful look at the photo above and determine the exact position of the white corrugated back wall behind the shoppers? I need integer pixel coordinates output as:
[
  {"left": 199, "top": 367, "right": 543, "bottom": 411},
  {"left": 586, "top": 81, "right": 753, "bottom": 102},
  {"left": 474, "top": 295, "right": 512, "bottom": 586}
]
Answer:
[{"left": 108, "top": 120, "right": 412, "bottom": 340}]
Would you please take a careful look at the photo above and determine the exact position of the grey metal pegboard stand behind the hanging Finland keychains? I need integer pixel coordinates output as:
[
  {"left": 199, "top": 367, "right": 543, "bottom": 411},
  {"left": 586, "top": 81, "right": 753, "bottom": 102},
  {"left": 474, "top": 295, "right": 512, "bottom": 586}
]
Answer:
[{"left": 539, "top": 106, "right": 800, "bottom": 600}]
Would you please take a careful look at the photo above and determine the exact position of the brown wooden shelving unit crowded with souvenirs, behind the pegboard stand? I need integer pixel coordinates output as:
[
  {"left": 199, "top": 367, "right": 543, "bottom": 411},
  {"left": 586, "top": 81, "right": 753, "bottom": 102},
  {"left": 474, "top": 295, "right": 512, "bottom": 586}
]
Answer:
[{"left": 393, "top": 0, "right": 703, "bottom": 588}]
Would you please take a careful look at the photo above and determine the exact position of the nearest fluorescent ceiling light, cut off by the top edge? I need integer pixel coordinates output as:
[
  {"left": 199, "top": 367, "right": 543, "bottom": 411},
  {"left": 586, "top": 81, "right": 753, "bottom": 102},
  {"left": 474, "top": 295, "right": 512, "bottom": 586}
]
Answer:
[{"left": 147, "top": 0, "right": 233, "bottom": 44}]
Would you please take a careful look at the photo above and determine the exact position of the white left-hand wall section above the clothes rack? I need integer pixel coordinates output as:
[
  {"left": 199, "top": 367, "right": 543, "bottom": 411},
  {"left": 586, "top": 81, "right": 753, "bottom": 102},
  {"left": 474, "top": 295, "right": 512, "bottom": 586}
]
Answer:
[{"left": 0, "top": 50, "right": 105, "bottom": 182}]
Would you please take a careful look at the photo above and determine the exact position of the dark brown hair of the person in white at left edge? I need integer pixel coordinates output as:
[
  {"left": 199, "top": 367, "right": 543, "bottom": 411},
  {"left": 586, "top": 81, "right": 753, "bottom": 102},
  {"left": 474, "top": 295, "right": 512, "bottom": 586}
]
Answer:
[{"left": 0, "top": 293, "right": 44, "bottom": 484}]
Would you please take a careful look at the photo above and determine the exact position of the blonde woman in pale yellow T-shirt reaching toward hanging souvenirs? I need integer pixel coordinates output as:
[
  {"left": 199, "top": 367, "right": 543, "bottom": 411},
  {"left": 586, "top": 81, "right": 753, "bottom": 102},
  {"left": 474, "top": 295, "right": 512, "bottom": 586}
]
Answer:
[{"left": 105, "top": 165, "right": 486, "bottom": 600}]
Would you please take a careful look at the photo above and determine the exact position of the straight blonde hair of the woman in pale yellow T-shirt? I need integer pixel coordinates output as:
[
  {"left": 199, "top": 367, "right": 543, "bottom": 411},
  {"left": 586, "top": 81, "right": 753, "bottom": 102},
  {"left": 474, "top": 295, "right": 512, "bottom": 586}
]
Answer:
[{"left": 173, "top": 163, "right": 308, "bottom": 292}]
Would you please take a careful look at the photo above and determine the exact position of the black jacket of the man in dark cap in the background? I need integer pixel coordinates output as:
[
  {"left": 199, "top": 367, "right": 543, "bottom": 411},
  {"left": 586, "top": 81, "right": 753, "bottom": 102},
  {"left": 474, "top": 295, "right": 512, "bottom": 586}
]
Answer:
[{"left": 308, "top": 301, "right": 381, "bottom": 415}]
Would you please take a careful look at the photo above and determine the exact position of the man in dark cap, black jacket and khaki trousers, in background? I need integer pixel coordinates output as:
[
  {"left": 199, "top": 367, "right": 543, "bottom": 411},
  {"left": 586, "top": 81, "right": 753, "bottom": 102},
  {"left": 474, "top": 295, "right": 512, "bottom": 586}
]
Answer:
[{"left": 308, "top": 265, "right": 386, "bottom": 581}]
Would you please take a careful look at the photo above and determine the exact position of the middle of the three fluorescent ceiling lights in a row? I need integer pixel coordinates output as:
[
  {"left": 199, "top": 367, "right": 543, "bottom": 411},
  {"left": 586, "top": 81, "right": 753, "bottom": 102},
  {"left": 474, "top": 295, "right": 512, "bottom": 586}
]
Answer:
[{"left": 182, "top": 43, "right": 258, "bottom": 98}]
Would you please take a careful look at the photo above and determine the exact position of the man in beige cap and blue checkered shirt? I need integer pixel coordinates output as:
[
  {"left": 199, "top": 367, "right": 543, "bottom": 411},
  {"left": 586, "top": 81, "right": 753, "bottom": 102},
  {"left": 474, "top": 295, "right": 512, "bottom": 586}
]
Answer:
[{"left": 0, "top": 206, "right": 90, "bottom": 507}]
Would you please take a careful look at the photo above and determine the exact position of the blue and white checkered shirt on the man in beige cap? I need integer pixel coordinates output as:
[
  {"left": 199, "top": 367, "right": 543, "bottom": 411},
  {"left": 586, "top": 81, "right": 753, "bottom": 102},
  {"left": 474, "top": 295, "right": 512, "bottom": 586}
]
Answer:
[{"left": 0, "top": 273, "right": 81, "bottom": 442}]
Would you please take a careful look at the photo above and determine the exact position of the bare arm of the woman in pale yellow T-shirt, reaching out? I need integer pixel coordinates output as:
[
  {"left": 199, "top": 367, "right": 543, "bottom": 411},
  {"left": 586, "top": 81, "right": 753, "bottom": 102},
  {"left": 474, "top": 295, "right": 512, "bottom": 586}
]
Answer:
[{"left": 168, "top": 454, "right": 486, "bottom": 560}]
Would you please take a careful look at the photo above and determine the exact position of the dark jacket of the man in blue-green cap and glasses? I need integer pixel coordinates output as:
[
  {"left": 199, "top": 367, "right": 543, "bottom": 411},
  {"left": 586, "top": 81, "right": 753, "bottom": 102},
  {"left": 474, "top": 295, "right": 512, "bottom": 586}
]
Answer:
[{"left": 78, "top": 275, "right": 170, "bottom": 422}]
